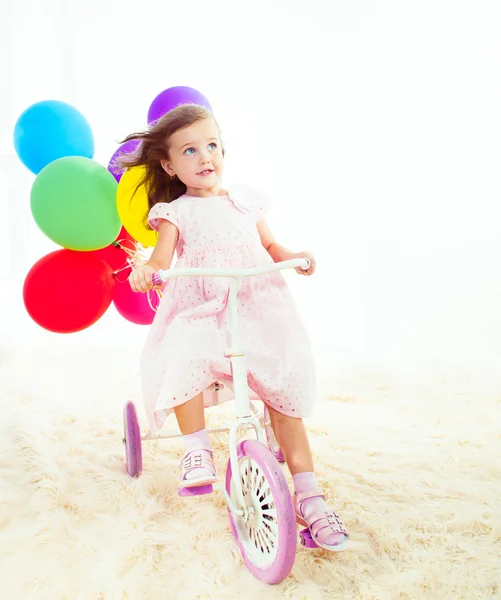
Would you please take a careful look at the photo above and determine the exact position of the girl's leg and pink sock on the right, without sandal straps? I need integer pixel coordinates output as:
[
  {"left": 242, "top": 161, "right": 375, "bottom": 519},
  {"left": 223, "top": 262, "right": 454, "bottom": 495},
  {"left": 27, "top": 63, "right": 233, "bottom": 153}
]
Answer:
[{"left": 268, "top": 406, "right": 346, "bottom": 548}]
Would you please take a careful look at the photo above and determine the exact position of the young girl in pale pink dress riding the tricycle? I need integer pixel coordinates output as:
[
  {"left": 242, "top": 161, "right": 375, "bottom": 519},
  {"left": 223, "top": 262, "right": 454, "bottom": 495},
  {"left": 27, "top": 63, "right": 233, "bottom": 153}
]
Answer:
[{"left": 121, "top": 104, "right": 348, "bottom": 551}]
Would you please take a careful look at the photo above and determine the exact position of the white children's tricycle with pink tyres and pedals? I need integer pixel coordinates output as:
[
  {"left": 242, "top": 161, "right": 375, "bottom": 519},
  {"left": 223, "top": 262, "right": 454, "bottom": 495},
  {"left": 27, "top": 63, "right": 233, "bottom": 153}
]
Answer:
[{"left": 123, "top": 258, "right": 317, "bottom": 583}]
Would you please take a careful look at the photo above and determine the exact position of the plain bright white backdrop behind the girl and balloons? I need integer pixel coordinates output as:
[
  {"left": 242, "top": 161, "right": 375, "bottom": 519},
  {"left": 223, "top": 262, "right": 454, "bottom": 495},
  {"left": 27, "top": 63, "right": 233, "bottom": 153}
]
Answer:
[{"left": 0, "top": 0, "right": 501, "bottom": 363}]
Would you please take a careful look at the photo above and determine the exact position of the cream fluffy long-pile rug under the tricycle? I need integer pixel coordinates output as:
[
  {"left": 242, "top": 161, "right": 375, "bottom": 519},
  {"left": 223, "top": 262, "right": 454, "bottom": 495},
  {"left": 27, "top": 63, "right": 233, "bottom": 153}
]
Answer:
[{"left": 0, "top": 334, "right": 501, "bottom": 600}]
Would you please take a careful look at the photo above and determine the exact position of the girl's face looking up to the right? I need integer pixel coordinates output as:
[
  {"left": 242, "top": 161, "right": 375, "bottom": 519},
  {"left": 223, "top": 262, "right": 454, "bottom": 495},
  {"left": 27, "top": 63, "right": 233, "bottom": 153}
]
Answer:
[{"left": 162, "top": 118, "right": 224, "bottom": 197}]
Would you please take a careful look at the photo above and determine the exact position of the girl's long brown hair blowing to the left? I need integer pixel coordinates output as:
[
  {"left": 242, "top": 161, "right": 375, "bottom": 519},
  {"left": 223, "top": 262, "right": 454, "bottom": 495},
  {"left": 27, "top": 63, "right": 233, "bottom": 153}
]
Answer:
[{"left": 117, "top": 104, "right": 224, "bottom": 220}]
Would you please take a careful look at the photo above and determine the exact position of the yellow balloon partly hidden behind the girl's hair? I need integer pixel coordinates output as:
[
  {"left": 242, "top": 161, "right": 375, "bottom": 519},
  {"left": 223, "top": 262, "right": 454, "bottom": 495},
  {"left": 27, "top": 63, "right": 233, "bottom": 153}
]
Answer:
[{"left": 117, "top": 167, "right": 158, "bottom": 247}]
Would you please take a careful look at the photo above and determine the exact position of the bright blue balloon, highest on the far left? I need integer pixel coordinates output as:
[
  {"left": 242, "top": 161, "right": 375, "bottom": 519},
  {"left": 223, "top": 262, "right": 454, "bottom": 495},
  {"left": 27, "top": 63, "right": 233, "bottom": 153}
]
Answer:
[{"left": 14, "top": 100, "right": 94, "bottom": 175}]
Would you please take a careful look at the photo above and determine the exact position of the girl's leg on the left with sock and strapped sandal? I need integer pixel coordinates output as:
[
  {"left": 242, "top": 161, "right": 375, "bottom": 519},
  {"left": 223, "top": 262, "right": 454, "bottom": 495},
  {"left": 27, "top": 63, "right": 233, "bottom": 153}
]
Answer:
[{"left": 174, "top": 394, "right": 216, "bottom": 485}]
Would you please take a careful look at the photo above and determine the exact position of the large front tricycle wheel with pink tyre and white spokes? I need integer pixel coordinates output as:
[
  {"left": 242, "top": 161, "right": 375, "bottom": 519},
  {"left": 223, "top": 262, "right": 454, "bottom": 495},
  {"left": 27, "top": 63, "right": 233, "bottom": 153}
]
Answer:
[{"left": 226, "top": 440, "right": 297, "bottom": 583}]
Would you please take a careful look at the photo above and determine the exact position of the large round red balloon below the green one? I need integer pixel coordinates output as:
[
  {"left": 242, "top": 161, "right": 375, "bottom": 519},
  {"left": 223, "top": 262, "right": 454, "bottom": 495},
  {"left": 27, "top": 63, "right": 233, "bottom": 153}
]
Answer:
[{"left": 23, "top": 250, "right": 115, "bottom": 333}]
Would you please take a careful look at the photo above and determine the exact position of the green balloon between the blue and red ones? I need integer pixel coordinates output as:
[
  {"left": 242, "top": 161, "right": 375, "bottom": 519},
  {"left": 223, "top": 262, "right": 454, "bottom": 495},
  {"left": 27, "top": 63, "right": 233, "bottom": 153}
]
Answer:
[{"left": 31, "top": 156, "right": 122, "bottom": 250}]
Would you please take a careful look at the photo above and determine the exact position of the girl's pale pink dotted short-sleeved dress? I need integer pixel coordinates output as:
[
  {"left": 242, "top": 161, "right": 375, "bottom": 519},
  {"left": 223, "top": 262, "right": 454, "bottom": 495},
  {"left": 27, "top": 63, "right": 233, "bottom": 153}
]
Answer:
[{"left": 141, "top": 186, "right": 315, "bottom": 432}]
